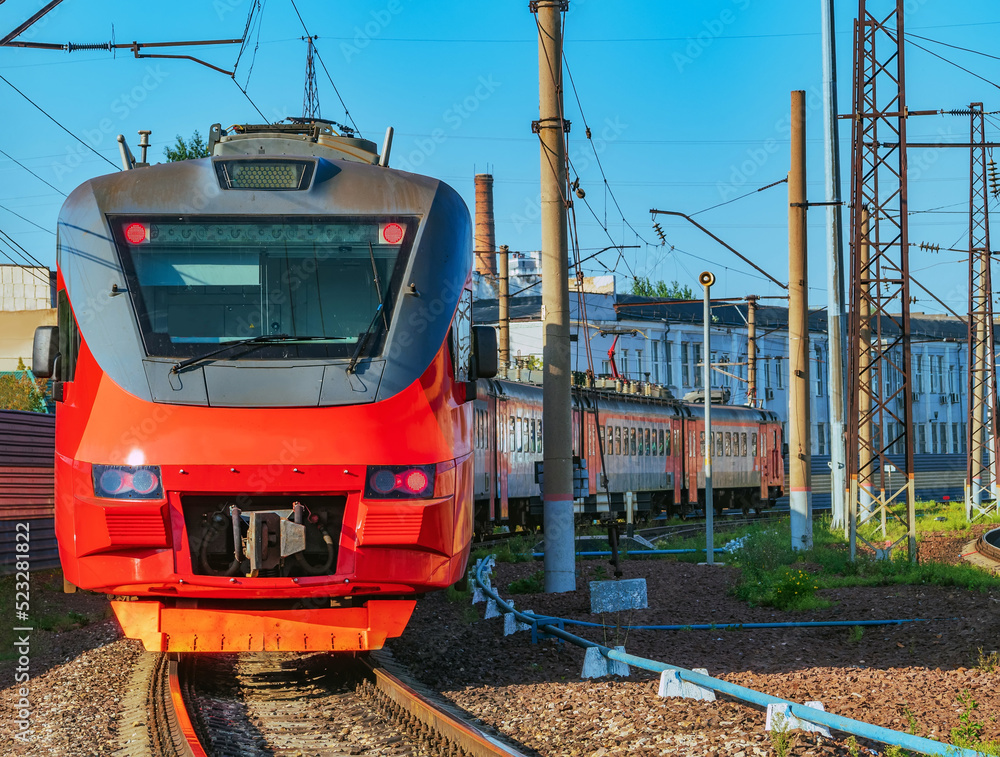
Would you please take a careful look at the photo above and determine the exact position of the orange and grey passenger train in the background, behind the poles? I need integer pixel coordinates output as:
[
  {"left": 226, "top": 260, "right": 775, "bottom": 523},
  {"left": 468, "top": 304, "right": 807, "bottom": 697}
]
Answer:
[{"left": 474, "top": 380, "right": 784, "bottom": 533}]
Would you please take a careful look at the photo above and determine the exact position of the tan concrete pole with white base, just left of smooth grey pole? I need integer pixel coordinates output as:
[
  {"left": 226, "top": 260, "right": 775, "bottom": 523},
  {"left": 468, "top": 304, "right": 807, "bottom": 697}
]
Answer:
[{"left": 788, "top": 89, "right": 812, "bottom": 550}]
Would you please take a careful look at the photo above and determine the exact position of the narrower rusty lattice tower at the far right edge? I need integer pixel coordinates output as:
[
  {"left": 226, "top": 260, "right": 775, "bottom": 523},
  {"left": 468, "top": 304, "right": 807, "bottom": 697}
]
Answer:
[{"left": 965, "top": 103, "right": 1000, "bottom": 521}]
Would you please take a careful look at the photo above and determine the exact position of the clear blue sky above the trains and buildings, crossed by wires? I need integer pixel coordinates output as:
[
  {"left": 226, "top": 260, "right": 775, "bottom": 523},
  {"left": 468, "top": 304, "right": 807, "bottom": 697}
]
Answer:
[{"left": 0, "top": 0, "right": 1000, "bottom": 312}]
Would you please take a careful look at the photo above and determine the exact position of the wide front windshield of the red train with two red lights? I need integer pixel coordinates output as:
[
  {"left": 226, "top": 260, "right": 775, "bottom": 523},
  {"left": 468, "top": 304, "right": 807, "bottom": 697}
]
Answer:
[{"left": 109, "top": 216, "right": 417, "bottom": 359}]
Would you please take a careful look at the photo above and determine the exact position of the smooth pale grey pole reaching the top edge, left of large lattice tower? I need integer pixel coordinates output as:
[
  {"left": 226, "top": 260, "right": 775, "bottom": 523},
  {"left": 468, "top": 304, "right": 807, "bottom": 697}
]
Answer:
[{"left": 817, "top": 0, "right": 848, "bottom": 528}]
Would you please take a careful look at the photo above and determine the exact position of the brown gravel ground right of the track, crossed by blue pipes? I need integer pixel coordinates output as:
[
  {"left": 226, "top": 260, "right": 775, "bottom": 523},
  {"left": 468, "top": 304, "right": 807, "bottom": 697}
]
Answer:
[{"left": 392, "top": 533, "right": 1000, "bottom": 757}]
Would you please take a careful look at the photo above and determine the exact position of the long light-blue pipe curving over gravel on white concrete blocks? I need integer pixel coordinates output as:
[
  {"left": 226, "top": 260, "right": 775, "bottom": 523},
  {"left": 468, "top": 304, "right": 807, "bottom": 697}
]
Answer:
[{"left": 476, "top": 559, "right": 982, "bottom": 757}]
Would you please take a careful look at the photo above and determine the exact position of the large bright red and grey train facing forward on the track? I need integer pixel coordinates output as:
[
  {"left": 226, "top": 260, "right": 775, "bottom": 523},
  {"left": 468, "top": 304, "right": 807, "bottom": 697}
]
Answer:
[{"left": 34, "top": 121, "right": 496, "bottom": 651}]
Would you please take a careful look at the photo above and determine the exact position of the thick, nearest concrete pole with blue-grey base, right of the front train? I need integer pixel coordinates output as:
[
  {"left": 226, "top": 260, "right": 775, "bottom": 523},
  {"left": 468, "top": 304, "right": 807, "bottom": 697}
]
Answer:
[{"left": 531, "top": 0, "right": 576, "bottom": 593}]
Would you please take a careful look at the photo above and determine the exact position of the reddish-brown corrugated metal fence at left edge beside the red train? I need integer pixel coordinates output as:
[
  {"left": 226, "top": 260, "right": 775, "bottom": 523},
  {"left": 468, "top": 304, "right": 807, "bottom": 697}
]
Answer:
[{"left": 0, "top": 410, "right": 59, "bottom": 573}]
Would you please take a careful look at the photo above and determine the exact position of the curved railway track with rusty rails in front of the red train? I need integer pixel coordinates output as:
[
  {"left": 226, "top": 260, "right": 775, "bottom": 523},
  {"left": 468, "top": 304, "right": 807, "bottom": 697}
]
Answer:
[{"left": 115, "top": 653, "right": 524, "bottom": 757}]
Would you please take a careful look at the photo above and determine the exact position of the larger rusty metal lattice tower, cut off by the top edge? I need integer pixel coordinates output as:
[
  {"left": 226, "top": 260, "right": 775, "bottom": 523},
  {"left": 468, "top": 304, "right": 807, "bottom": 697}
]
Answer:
[{"left": 847, "top": 0, "right": 917, "bottom": 561}]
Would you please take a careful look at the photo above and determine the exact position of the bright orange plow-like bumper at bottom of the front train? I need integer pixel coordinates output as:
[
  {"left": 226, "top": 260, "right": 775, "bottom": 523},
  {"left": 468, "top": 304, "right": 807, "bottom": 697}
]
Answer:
[{"left": 111, "top": 599, "right": 416, "bottom": 652}]
